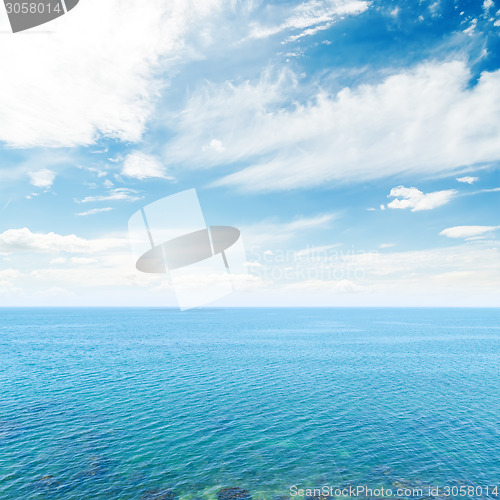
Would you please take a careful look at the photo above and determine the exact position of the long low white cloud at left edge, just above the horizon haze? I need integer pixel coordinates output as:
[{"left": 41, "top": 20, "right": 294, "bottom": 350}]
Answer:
[{"left": 0, "top": 227, "right": 124, "bottom": 253}]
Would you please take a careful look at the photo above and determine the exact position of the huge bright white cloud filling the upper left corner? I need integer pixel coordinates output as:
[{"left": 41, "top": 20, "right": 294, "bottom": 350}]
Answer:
[{"left": 0, "top": 0, "right": 226, "bottom": 147}]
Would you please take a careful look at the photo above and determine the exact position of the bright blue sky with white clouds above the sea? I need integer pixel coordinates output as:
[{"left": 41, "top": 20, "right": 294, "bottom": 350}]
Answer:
[{"left": 0, "top": 0, "right": 500, "bottom": 306}]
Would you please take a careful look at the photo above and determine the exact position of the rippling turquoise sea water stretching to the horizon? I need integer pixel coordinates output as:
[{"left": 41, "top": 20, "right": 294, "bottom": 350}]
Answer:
[{"left": 0, "top": 309, "right": 500, "bottom": 500}]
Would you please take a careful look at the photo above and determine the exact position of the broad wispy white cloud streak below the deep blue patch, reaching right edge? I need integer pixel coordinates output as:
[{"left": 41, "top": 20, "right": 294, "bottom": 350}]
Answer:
[{"left": 164, "top": 61, "right": 500, "bottom": 191}]
